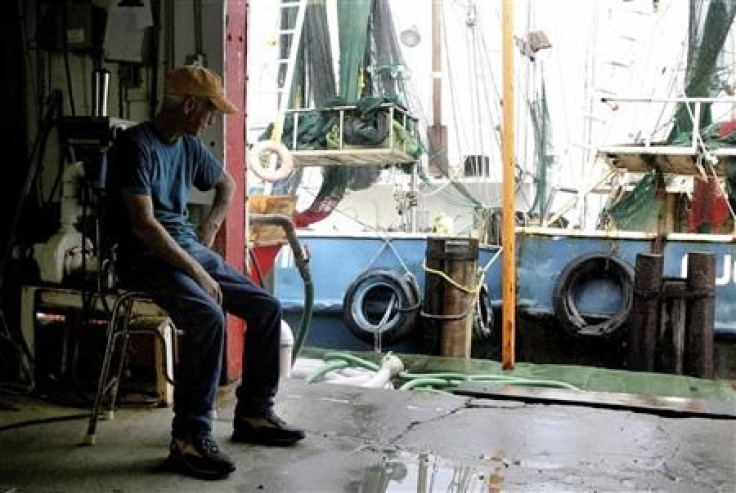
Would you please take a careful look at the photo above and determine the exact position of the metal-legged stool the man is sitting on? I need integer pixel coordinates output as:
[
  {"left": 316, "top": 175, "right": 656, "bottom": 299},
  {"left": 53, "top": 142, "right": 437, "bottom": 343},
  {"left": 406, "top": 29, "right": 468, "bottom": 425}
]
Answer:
[{"left": 84, "top": 291, "right": 177, "bottom": 445}]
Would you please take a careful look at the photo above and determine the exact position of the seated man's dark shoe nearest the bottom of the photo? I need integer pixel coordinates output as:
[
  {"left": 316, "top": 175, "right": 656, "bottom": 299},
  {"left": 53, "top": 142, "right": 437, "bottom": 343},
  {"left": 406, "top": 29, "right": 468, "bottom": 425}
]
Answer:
[{"left": 169, "top": 431, "right": 235, "bottom": 479}]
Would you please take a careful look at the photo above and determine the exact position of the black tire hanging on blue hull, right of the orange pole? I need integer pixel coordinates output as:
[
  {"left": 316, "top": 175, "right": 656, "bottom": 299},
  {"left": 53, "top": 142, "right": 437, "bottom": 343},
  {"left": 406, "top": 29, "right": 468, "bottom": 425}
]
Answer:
[{"left": 552, "top": 253, "right": 634, "bottom": 340}]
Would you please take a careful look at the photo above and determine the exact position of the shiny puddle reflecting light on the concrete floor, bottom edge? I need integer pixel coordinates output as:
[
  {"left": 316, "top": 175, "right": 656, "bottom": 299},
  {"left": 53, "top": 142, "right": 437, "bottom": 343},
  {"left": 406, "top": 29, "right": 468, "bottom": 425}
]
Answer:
[{"left": 346, "top": 454, "right": 508, "bottom": 493}]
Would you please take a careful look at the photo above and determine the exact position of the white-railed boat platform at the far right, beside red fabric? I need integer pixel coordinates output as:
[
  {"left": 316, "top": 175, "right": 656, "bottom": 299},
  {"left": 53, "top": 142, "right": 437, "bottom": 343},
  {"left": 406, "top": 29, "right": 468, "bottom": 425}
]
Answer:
[{"left": 598, "top": 97, "right": 736, "bottom": 177}]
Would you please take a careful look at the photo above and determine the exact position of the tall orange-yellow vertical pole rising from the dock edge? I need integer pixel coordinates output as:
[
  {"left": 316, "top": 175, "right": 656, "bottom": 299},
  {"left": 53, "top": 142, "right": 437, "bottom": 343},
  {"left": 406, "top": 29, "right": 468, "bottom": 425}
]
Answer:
[{"left": 501, "top": 0, "right": 516, "bottom": 370}]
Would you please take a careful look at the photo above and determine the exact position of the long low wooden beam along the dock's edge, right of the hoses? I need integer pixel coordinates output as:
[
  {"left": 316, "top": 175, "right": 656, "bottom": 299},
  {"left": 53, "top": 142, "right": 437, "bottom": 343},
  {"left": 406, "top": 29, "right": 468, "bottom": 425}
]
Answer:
[{"left": 453, "top": 382, "right": 736, "bottom": 419}]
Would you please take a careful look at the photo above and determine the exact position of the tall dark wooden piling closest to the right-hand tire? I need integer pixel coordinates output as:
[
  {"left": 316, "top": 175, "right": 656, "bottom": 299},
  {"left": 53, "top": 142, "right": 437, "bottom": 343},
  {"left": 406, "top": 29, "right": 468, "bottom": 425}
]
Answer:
[{"left": 628, "top": 253, "right": 664, "bottom": 371}]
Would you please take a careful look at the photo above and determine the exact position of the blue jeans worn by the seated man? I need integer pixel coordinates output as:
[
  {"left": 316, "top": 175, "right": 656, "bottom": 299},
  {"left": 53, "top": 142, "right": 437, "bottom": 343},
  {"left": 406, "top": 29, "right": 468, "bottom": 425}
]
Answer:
[{"left": 123, "top": 247, "right": 282, "bottom": 435}]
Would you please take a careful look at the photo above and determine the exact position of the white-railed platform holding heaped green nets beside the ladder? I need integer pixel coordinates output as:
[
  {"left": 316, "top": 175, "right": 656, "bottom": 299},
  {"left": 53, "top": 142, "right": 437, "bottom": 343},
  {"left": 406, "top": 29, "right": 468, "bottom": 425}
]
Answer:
[{"left": 286, "top": 103, "right": 419, "bottom": 166}]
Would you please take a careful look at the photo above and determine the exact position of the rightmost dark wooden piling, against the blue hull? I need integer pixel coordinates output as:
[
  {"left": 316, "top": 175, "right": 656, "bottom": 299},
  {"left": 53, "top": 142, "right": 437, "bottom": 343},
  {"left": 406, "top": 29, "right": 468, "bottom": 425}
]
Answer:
[{"left": 683, "top": 252, "right": 716, "bottom": 378}]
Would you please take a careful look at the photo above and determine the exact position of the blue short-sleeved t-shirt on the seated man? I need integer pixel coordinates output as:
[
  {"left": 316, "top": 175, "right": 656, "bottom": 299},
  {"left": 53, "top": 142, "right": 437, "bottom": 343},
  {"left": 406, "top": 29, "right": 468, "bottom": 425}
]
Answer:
[{"left": 107, "top": 122, "right": 222, "bottom": 261}]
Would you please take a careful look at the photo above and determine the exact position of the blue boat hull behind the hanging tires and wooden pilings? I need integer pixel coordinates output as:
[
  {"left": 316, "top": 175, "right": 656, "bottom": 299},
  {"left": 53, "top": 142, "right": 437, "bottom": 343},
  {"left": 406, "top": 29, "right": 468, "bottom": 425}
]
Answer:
[{"left": 273, "top": 228, "right": 736, "bottom": 353}]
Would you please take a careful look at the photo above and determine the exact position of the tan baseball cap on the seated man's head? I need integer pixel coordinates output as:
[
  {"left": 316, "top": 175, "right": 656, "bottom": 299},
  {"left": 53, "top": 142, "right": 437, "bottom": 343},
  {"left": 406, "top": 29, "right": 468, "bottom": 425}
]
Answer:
[{"left": 164, "top": 65, "right": 238, "bottom": 113}]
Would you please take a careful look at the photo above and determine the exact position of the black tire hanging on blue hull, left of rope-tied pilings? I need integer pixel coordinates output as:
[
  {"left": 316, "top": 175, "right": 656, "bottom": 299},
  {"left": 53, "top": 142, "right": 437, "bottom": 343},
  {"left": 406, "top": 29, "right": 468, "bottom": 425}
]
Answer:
[{"left": 342, "top": 269, "right": 421, "bottom": 346}]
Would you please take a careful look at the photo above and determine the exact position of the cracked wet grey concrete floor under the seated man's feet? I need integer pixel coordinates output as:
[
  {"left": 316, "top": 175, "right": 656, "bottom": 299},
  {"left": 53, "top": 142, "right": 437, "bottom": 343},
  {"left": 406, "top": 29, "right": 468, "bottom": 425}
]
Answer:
[{"left": 0, "top": 380, "right": 736, "bottom": 493}]
